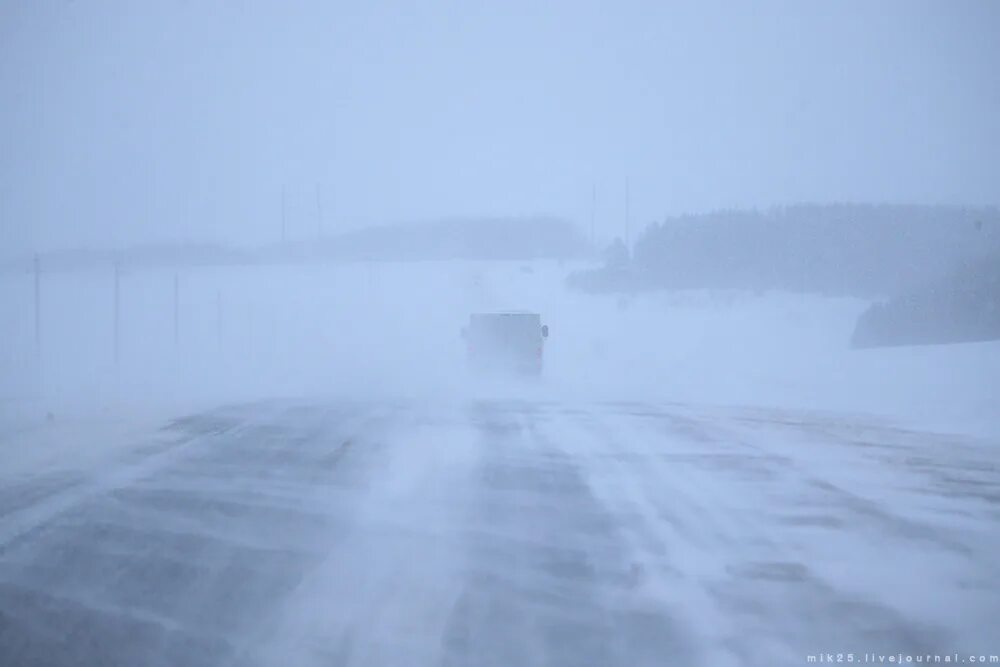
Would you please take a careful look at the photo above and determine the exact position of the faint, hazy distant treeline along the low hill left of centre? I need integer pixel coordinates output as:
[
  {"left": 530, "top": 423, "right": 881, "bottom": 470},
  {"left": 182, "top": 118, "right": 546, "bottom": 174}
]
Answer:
[{"left": 0, "top": 218, "right": 589, "bottom": 271}]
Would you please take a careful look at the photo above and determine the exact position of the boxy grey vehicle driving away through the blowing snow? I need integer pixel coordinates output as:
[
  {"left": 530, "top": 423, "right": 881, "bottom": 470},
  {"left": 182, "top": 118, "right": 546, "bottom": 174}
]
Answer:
[{"left": 462, "top": 312, "right": 549, "bottom": 375}]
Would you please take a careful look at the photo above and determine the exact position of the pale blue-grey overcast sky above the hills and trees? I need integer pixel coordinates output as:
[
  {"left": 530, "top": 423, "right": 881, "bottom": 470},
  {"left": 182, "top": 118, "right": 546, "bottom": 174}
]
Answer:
[{"left": 0, "top": 0, "right": 1000, "bottom": 252}]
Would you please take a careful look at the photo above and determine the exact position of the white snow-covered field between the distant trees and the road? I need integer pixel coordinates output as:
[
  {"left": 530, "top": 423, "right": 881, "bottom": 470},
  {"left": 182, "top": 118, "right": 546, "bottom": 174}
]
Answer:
[{"left": 0, "top": 262, "right": 1000, "bottom": 433}]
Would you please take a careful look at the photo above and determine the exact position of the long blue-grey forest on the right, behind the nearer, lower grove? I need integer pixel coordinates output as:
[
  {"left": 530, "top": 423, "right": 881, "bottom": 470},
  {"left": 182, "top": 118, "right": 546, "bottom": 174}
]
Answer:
[{"left": 571, "top": 204, "right": 1000, "bottom": 298}]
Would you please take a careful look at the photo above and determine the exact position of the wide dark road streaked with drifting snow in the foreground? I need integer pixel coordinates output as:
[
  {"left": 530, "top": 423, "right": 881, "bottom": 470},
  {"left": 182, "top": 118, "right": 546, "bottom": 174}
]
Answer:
[{"left": 0, "top": 401, "right": 1000, "bottom": 667}]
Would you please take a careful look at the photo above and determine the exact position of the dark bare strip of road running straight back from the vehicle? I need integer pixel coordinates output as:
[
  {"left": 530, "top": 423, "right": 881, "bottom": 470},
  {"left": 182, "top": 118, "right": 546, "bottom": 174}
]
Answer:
[{"left": 443, "top": 403, "right": 691, "bottom": 667}]
